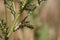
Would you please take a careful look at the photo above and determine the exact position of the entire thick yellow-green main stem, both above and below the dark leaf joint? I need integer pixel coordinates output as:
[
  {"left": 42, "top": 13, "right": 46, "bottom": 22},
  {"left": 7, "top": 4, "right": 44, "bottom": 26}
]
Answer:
[{"left": 7, "top": 0, "right": 27, "bottom": 37}]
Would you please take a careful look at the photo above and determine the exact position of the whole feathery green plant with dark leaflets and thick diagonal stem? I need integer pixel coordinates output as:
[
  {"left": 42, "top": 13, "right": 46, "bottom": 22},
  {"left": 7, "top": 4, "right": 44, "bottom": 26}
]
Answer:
[{"left": 0, "top": 0, "right": 46, "bottom": 40}]
